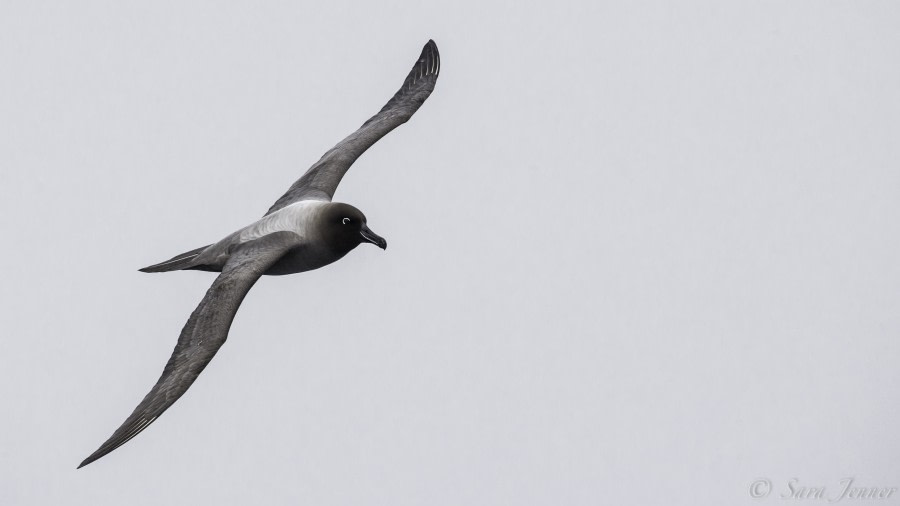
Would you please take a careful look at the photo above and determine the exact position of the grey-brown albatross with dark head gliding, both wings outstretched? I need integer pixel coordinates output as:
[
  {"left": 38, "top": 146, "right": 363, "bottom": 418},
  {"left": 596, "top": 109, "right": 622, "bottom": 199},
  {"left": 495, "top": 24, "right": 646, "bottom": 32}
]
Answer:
[{"left": 78, "top": 40, "right": 441, "bottom": 469}]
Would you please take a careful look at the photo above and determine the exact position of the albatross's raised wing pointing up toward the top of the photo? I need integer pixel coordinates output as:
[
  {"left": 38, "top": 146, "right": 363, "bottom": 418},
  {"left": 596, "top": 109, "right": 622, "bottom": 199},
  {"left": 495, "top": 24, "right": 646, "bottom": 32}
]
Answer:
[{"left": 266, "top": 40, "right": 441, "bottom": 215}]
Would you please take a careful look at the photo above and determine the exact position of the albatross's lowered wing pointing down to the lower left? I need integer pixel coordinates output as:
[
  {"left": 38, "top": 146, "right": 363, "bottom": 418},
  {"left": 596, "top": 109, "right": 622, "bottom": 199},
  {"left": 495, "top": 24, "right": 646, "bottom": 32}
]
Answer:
[{"left": 78, "top": 232, "right": 299, "bottom": 469}]
